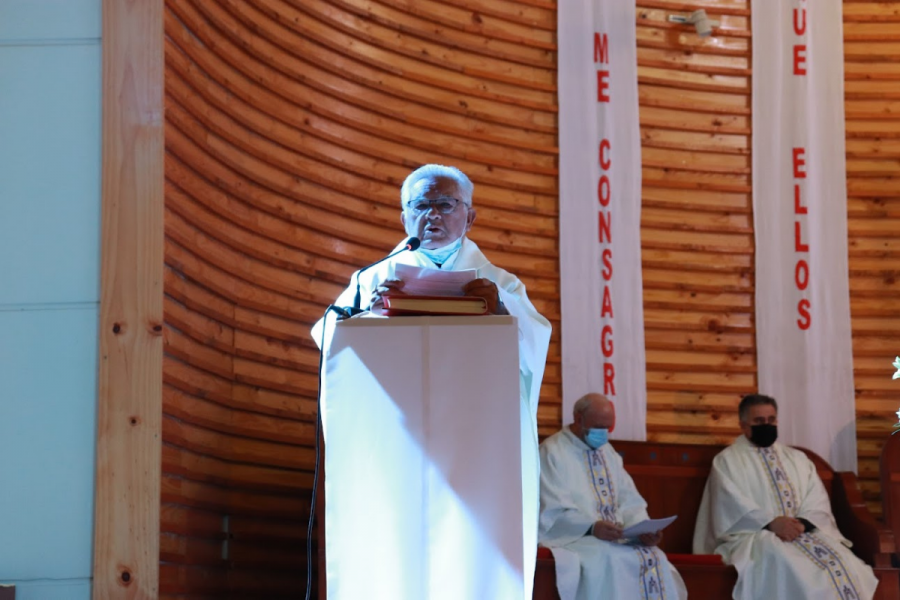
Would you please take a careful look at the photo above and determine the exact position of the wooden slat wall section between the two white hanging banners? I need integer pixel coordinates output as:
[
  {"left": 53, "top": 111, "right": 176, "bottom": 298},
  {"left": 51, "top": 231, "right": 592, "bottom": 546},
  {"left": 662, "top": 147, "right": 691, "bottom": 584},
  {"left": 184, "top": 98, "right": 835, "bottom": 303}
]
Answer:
[{"left": 637, "top": 0, "right": 756, "bottom": 444}]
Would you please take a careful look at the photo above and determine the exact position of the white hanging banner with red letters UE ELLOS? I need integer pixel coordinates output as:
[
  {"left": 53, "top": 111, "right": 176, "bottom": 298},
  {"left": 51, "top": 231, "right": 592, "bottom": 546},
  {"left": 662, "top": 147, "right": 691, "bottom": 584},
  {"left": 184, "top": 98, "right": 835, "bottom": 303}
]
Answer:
[{"left": 752, "top": 0, "right": 856, "bottom": 471}]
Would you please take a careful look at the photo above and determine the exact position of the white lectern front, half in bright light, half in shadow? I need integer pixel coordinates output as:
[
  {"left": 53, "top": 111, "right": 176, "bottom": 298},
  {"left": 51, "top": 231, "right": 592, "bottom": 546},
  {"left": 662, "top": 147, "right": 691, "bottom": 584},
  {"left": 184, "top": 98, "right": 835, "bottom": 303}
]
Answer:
[{"left": 319, "top": 316, "right": 533, "bottom": 600}]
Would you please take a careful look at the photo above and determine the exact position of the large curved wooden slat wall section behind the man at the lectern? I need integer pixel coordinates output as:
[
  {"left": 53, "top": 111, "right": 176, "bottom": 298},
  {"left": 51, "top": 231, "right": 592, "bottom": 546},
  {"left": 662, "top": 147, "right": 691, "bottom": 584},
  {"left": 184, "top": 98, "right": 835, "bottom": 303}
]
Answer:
[{"left": 160, "top": 0, "right": 560, "bottom": 598}]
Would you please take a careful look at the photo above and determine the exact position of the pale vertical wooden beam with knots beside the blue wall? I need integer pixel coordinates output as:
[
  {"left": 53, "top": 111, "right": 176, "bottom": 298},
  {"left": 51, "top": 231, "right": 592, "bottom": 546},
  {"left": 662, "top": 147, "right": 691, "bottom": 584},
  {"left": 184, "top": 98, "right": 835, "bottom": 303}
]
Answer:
[{"left": 93, "top": 0, "right": 164, "bottom": 599}]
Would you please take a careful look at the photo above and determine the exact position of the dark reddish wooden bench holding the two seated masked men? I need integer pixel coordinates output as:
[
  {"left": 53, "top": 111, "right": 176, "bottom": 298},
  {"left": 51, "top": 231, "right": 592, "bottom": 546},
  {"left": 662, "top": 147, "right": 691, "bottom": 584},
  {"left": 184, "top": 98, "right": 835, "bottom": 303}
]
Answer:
[{"left": 534, "top": 435, "right": 900, "bottom": 600}]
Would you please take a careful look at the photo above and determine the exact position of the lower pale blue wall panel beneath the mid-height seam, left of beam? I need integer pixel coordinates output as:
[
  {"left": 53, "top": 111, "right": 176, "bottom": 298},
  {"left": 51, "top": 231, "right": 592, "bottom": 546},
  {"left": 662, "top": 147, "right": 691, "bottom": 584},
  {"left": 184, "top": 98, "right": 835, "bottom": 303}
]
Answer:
[{"left": 0, "top": 306, "right": 98, "bottom": 581}]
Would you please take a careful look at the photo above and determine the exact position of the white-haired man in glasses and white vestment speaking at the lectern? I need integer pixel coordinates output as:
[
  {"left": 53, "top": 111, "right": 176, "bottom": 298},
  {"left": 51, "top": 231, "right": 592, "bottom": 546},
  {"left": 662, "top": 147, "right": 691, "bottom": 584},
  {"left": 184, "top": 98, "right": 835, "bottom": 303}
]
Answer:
[{"left": 313, "top": 164, "right": 551, "bottom": 599}]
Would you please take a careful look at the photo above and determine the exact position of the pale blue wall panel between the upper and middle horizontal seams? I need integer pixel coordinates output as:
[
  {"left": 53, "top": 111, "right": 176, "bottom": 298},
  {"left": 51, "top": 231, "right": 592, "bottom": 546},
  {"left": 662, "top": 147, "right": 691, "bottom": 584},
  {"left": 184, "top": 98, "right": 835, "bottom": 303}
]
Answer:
[{"left": 0, "top": 43, "right": 101, "bottom": 305}]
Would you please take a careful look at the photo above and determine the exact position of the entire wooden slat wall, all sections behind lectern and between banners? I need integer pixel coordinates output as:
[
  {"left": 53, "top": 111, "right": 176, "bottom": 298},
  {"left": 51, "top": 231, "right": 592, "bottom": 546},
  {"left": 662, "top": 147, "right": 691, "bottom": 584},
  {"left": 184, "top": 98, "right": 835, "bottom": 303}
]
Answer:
[{"left": 160, "top": 0, "right": 900, "bottom": 597}]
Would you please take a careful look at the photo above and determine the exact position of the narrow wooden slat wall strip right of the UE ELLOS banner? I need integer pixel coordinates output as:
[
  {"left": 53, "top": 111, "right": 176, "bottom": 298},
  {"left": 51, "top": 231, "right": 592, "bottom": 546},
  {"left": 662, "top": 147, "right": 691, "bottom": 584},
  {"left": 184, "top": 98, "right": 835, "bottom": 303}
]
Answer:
[{"left": 843, "top": 0, "right": 900, "bottom": 514}]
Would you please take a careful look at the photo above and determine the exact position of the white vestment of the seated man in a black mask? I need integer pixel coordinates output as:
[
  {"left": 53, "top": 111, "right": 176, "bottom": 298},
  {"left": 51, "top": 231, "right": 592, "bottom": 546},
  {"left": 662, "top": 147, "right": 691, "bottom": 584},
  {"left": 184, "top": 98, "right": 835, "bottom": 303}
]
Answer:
[{"left": 694, "top": 435, "right": 878, "bottom": 600}]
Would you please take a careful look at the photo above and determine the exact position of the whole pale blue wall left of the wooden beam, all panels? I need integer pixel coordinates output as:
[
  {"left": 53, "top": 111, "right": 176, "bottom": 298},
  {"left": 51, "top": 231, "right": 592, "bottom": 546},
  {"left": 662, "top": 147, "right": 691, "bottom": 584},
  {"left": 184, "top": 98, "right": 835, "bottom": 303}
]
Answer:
[{"left": 0, "top": 0, "right": 101, "bottom": 600}]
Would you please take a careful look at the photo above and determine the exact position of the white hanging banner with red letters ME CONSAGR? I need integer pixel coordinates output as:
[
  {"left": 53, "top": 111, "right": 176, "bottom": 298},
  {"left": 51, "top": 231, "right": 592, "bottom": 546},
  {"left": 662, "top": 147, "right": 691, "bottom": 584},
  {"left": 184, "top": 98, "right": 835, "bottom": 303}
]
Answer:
[{"left": 557, "top": 0, "right": 647, "bottom": 440}]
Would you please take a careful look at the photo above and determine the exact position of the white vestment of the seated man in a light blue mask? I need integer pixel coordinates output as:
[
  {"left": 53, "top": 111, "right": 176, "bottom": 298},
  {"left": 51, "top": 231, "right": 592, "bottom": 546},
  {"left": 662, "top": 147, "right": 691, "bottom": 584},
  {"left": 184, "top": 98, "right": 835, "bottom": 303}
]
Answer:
[{"left": 538, "top": 427, "right": 687, "bottom": 600}]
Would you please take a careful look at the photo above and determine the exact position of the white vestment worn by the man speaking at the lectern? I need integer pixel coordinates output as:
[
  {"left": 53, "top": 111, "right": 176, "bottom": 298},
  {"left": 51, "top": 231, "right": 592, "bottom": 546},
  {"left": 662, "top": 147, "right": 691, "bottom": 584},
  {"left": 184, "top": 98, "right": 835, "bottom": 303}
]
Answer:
[{"left": 312, "top": 237, "right": 551, "bottom": 600}]
